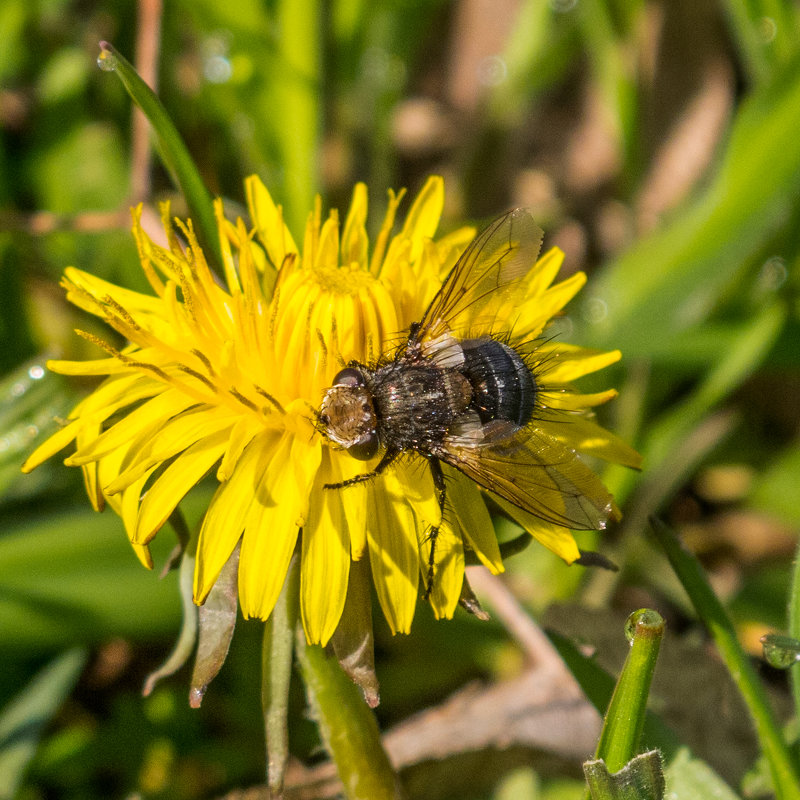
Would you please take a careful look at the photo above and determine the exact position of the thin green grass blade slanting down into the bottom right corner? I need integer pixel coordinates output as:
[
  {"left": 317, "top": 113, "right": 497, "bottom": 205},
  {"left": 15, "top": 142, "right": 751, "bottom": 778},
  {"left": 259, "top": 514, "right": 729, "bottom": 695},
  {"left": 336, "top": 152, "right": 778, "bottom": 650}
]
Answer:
[{"left": 651, "top": 518, "right": 800, "bottom": 800}]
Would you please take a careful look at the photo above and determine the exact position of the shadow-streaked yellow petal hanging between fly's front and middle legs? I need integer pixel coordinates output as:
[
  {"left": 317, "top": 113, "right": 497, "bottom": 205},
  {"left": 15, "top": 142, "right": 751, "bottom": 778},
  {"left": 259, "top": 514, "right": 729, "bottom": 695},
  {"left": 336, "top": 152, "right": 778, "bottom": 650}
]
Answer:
[{"left": 367, "top": 473, "right": 419, "bottom": 633}]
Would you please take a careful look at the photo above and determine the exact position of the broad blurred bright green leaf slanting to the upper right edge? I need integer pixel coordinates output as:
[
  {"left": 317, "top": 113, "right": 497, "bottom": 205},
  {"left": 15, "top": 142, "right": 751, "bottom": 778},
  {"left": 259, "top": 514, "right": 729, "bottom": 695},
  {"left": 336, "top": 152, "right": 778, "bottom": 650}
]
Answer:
[{"left": 584, "top": 51, "right": 800, "bottom": 358}]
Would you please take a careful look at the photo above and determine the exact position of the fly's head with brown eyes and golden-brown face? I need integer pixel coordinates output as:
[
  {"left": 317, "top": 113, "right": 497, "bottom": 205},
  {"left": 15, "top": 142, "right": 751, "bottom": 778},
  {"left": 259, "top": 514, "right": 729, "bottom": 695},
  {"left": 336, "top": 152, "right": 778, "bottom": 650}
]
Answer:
[{"left": 319, "top": 367, "right": 378, "bottom": 461}]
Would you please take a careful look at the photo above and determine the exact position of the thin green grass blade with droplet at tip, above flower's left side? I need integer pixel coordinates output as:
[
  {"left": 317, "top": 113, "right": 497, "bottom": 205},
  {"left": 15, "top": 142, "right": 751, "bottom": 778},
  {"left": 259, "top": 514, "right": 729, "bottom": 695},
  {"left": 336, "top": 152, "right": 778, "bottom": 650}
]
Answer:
[{"left": 97, "top": 42, "right": 222, "bottom": 267}]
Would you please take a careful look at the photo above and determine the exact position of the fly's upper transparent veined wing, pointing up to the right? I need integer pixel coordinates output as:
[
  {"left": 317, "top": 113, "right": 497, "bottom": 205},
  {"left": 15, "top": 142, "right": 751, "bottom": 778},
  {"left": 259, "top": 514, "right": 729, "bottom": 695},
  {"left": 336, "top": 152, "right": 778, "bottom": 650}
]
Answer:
[{"left": 409, "top": 208, "right": 543, "bottom": 343}]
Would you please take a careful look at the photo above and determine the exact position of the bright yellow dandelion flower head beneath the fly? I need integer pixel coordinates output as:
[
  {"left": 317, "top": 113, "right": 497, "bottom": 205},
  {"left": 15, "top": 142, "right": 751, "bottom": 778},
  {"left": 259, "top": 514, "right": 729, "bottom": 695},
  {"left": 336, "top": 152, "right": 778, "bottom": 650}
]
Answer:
[{"left": 24, "top": 178, "right": 638, "bottom": 644}]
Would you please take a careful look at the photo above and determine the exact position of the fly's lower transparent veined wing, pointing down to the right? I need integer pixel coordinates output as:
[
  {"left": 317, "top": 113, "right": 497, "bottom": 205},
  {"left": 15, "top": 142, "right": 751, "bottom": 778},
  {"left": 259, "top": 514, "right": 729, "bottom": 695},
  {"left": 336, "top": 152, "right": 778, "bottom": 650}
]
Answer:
[{"left": 437, "top": 421, "right": 618, "bottom": 530}]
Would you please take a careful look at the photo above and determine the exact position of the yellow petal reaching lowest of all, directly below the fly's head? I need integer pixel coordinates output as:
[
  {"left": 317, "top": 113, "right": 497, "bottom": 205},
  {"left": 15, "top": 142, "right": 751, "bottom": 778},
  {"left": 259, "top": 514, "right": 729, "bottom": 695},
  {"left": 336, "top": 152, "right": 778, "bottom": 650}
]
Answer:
[{"left": 300, "top": 448, "right": 350, "bottom": 646}]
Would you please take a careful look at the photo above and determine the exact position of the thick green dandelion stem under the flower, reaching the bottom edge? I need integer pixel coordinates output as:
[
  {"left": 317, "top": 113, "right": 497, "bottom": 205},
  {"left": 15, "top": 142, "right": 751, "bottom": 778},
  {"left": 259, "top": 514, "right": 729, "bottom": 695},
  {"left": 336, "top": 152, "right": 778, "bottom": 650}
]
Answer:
[{"left": 297, "top": 626, "right": 403, "bottom": 800}]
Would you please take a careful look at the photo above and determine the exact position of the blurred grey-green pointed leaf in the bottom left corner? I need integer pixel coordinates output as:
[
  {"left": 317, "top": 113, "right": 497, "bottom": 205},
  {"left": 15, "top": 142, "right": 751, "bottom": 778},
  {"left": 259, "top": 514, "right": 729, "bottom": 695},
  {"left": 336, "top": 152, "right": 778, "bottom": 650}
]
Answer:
[{"left": 0, "top": 649, "right": 86, "bottom": 800}]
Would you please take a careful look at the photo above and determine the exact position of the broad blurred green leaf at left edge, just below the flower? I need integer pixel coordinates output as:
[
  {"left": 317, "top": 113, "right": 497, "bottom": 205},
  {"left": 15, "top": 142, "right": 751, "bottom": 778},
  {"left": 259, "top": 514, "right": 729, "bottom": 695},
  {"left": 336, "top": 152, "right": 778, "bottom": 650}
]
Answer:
[{"left": 0, "top": 509, "right": 180, "bottom": 651}]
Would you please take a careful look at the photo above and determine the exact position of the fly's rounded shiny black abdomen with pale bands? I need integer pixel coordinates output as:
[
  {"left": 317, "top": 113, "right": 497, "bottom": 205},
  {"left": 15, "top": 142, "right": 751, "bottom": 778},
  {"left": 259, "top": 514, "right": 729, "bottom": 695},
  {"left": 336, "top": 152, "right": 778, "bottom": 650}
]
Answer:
[{"left": 461, "top": 339, "right": 536, "bottom": 427}]
